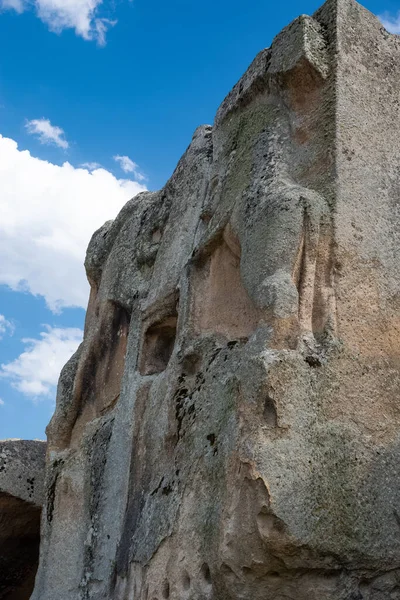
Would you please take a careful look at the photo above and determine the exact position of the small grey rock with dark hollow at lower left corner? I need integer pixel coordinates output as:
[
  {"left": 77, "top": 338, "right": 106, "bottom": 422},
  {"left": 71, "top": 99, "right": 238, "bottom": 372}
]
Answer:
[{"left": 0, "top": 440, "right": 46, "bottom": 600}]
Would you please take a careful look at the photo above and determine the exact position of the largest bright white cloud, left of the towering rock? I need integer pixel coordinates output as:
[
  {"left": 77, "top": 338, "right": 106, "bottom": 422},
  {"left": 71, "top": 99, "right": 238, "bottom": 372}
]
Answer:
[{"left": 0, "top": 135, "right": 145, "bottom": 311}]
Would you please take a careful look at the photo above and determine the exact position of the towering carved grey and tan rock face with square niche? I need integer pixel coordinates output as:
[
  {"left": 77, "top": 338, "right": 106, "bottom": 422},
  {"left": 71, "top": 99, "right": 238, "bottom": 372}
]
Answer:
[{"left": 33, "top": 0, "right": 400, "bottom": 600}]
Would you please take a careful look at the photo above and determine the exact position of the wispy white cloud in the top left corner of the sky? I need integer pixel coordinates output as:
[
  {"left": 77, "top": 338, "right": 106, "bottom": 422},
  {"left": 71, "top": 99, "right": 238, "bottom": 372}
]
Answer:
[{"left": 0, "top": 0, "right": 116, "bottom": 46}]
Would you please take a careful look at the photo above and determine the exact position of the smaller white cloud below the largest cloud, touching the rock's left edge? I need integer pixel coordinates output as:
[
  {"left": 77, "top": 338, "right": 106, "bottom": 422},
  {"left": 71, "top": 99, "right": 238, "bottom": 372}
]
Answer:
[{"left": 0, "top": 326, "right": 83, "bottom": 398}]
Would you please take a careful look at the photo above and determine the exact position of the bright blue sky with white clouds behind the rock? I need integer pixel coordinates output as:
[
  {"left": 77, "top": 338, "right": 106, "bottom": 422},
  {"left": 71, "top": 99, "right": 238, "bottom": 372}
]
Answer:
[{"left": 0, "top": 0, "right": 400, "bottom": 439}]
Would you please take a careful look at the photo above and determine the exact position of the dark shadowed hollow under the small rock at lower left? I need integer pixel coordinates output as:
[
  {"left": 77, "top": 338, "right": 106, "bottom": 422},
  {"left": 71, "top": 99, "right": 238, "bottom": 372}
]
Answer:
[{"left": 0, "top": 493, "right": 41, "bottom": 600}]
